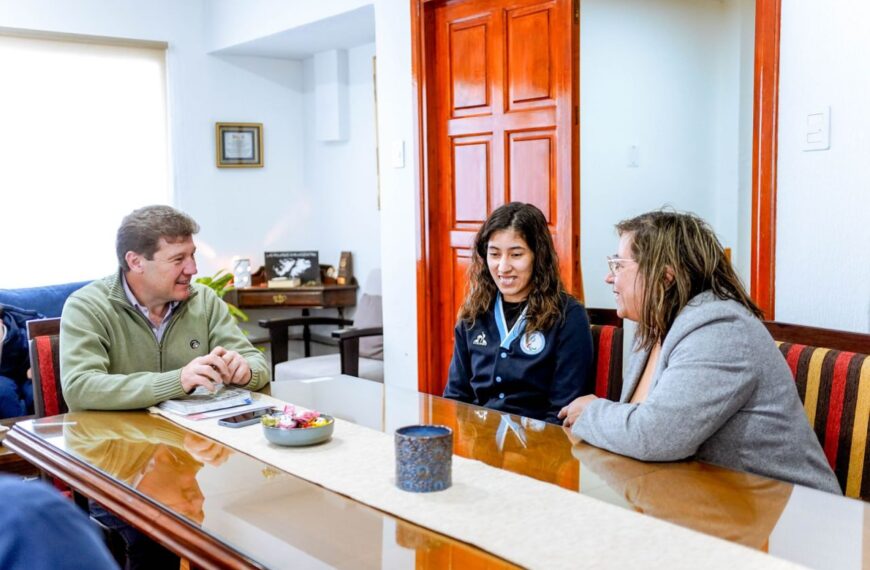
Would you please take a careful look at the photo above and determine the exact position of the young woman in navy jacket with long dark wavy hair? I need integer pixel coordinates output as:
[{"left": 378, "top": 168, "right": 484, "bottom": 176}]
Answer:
[{"left": 444, "top": 202, "right": 593, "bottom": 423}]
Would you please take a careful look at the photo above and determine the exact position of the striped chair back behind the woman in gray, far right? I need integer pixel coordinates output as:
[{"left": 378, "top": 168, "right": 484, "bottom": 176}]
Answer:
[{"left": 777, "top": 342, "right": 870, "bottom": 500}]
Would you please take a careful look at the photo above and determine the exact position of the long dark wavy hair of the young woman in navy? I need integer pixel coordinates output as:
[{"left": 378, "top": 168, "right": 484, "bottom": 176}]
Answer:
[{"left": 459, "top": 202, "right": 565, "bottom": 332}]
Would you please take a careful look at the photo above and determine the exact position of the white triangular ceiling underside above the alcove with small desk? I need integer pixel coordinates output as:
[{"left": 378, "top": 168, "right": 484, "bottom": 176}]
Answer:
[{"left": 214, "top": 5, "right": 375, "bottom": 59}]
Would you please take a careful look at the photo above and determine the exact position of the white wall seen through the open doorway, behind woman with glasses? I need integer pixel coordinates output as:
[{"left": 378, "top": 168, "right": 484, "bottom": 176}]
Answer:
[{"left": 580, "top": 0, "right": 754, "bottom": 307}]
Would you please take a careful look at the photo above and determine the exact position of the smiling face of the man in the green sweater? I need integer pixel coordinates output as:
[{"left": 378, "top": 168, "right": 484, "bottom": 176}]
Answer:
[{"left": 126, "top": 236, "right": 196, "bottom": 308}]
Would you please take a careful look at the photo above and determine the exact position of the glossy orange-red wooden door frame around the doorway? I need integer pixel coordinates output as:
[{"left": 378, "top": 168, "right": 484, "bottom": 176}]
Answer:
[{"left": 409, "top": 0, "right": 782, "bottom": 393}]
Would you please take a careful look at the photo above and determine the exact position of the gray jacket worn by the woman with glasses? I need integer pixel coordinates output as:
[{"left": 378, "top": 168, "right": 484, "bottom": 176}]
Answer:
[{"left": 572, "top": 291, "right": 842, "bottom": 494}]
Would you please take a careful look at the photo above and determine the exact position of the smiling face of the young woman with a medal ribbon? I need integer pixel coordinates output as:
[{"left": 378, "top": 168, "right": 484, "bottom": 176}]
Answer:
[{"left": 486, "top": 228, "right": 535, "bottom": 303}]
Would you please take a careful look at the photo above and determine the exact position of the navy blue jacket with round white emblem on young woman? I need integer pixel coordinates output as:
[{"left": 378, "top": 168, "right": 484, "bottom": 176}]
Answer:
[{"left": 444, "top": 295, "right": 594, "bottom": 423}]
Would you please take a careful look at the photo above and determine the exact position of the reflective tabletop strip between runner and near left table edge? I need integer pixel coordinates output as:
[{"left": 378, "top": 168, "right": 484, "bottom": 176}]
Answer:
[{"left": 30, "top": 412, "right": 514, "bottom": 570}]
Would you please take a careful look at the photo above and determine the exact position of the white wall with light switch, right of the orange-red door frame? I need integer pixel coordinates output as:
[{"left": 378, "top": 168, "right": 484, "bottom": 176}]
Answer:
[{"left": 776, "top": 0, "right": 870, "bottom": 332}]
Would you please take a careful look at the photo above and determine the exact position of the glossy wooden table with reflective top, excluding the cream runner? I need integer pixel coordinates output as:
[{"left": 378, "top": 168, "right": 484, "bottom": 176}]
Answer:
[{"left": 6, "top": 377, "right": 870, "bottom": 569}]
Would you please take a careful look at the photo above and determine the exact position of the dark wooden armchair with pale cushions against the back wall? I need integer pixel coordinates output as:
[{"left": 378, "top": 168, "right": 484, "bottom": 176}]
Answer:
[{"left": 258, "top": 270, "right": 384, "bottom": 382}]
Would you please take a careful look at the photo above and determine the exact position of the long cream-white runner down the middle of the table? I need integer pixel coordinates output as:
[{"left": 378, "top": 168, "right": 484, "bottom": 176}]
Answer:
[{"left": 152, "top": 394, "right": 797, "bottom": 570}]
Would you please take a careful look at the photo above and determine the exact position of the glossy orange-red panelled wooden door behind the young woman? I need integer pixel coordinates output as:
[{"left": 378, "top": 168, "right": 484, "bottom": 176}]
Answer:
[{"left": 417, "top": 0, "right": 583, "bottom": 394}]
